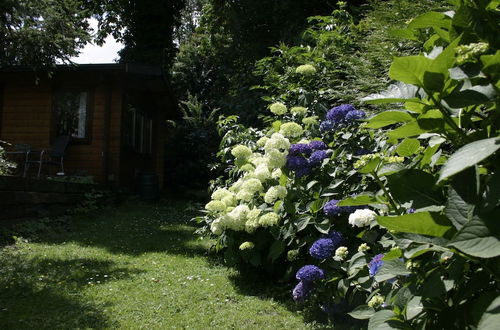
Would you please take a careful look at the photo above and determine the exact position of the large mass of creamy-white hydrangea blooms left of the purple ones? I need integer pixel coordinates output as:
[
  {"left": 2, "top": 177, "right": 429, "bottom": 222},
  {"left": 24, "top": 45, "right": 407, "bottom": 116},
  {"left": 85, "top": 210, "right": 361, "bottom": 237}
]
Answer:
[{"left": 205, "top": 133, "right": 294, "bottom": 235}]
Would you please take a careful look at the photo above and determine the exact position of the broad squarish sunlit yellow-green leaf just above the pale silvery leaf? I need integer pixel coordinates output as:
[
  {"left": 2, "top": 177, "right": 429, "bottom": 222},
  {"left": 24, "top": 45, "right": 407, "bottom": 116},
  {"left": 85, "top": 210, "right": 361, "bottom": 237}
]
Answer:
[{"left": 389, "top": 55, "right": 432, "bottom": 87}]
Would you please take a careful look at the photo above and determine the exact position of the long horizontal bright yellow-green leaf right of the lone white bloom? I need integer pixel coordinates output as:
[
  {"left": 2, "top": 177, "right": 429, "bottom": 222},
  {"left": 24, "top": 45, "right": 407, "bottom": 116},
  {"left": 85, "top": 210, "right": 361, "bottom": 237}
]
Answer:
[{"left": 377, "top": 212, "right": 456, "bottom": 238}]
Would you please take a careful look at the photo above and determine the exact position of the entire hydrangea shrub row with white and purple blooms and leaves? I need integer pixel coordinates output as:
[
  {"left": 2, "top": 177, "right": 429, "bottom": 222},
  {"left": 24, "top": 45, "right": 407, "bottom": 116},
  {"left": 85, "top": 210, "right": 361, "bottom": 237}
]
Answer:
[{"left": 197, "top": 1, "right": 500, "bottom": 329}]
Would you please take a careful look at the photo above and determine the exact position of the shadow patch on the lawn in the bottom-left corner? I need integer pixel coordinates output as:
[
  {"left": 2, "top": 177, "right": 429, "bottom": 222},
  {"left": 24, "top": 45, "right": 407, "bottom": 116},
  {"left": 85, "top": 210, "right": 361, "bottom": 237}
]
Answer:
[{"left": 0, "top": 251, "right": 139, "bottom": 329}]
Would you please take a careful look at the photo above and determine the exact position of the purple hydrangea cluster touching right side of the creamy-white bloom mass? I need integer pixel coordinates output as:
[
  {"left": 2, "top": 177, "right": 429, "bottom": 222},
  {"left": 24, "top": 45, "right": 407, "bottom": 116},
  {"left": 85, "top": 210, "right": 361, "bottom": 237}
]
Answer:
[{"left": 286, "top": 141, "right": 328, "bottom": 178}]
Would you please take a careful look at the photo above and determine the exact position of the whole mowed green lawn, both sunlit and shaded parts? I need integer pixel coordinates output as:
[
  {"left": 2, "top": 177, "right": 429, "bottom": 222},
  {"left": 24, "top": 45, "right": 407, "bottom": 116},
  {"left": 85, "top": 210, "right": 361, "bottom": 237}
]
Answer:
[{"left": 0, "top": 202, "right": 312, "bottom": 329}]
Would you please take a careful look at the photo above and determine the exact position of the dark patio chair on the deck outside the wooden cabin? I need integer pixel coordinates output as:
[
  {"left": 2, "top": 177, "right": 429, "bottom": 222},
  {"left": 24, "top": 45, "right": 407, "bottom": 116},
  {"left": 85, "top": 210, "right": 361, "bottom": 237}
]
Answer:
[{"left": 24, "top": 135, "right": 69, "bottom": 178}]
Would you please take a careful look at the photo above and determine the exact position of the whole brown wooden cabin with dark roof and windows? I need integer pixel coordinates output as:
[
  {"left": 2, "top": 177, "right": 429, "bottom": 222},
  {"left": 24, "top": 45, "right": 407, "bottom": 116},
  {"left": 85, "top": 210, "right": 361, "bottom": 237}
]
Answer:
[{"left": 0, "top": 64, "right": 175, "bottom": 188}]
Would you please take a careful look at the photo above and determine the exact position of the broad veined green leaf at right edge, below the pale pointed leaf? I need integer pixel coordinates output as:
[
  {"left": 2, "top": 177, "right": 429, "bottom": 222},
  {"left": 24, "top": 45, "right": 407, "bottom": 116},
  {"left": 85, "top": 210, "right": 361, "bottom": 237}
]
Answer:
[{"left": 449, "top": 210, "right": 500, "bottom": 258}]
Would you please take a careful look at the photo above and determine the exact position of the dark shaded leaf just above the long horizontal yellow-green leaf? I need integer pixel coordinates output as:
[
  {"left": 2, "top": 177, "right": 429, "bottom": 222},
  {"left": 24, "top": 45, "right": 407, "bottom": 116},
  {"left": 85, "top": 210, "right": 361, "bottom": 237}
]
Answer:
[{"left": 387, "top": 169, "right": 443, "bottom": 208}]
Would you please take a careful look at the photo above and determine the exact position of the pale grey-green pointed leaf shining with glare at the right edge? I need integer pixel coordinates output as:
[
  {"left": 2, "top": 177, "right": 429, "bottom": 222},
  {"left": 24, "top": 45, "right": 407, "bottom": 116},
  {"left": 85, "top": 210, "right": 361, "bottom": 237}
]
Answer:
[{"left": 438, "top": 137, "right": 500, "bottom": 182}]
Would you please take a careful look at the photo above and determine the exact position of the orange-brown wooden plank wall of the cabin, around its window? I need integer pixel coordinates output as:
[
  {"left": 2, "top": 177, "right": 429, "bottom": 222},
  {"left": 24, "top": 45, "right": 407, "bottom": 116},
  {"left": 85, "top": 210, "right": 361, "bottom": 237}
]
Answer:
[{"left": 0, "top": 72, "right": 122, "bottom": 182}]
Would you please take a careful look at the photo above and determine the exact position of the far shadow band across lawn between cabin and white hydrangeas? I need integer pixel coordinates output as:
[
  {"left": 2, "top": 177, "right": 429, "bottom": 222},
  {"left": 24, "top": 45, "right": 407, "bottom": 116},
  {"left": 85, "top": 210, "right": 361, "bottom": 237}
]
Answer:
[{"left": 0, "top": 201, "right": 210, "bottom": 257}]
